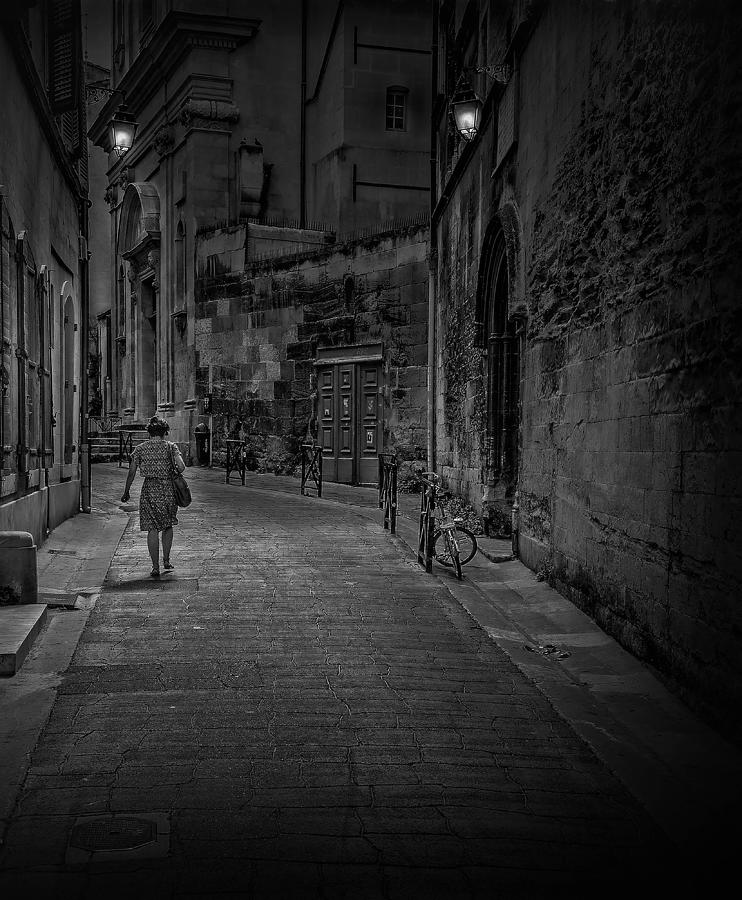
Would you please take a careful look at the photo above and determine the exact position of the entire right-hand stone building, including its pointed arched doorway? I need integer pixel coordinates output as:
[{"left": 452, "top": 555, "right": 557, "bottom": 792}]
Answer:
[{"left": 432, "top": 0, "right": 742, "bottom": 733}]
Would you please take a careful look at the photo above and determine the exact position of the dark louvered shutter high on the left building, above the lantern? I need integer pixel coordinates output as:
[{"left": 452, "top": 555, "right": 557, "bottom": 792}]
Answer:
[{"left": 49, "top": 0, "right": 81, "bottom": 115}]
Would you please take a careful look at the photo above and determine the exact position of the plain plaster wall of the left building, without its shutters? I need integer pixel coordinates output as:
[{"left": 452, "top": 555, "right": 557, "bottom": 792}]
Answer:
[{"left": 0, "top": 24, "right": 85, "bottom": 544}]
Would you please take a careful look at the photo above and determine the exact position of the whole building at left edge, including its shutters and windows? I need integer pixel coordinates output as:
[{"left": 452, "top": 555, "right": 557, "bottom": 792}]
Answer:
[{"left": 0, "top": 0, "right": 87, "bottom": 544}]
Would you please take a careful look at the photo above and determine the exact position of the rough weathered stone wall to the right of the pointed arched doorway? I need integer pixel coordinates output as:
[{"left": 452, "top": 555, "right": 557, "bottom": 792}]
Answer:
[{"left": 520, "top": 4, "right": 742, "bottom": 727}]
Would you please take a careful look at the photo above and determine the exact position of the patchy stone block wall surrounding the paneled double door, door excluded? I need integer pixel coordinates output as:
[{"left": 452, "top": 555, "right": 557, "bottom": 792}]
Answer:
[{"left": 195, "top": 227, "right": 428, "bottom": 472}]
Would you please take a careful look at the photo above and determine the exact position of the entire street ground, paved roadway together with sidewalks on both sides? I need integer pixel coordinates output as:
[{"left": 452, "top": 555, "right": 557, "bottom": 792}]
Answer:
[{"left": 0, "top": 465, "right": 742, "bottom": 898}]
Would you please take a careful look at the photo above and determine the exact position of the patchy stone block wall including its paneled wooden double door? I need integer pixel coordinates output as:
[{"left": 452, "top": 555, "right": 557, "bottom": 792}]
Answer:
[{"left": 195, "top": 217, "right": 429, "bottom": 484}]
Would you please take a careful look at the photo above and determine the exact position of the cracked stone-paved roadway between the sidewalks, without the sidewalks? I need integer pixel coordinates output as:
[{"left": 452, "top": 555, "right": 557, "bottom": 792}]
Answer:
[{"left": 0, "top": 478, "right": 676, "bottom": 900}]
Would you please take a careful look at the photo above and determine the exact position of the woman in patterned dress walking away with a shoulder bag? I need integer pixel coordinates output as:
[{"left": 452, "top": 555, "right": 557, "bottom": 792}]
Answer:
[{"left": 121, "top": 416, "right": 185, "bottom": 578}]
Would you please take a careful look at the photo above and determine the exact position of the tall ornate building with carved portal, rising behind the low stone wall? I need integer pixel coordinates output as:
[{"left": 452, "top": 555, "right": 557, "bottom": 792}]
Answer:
[{"left": 90, "top": 0, "right": 430, "bottom": 443}]
